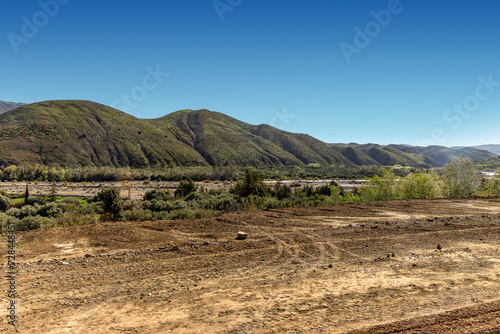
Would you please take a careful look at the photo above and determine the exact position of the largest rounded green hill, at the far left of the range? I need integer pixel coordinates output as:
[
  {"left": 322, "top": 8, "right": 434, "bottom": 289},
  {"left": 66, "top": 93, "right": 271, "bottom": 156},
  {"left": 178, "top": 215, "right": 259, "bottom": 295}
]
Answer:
[{"left": 0, "top": 101, "right": 206, "bottom": 167}]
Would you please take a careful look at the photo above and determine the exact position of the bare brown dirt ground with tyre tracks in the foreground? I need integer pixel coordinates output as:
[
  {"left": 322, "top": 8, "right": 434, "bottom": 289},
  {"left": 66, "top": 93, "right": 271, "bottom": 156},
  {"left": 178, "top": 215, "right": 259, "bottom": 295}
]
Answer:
[{"left": 0, "top": 199, "right": 500, "bottom": 334}]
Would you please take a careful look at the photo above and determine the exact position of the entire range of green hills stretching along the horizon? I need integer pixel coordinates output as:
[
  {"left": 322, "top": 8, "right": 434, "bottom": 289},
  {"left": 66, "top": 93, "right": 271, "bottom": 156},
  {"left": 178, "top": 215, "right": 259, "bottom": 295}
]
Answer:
[{"left": 0, "top": 100, "right": 497, "bottom": 168}]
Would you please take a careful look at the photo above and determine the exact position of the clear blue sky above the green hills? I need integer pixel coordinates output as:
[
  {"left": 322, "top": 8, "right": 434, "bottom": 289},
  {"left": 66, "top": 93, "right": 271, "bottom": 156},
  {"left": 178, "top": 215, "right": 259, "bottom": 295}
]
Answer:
[{"left": 0, "top": 0, "right": 500, "bottom": 146}]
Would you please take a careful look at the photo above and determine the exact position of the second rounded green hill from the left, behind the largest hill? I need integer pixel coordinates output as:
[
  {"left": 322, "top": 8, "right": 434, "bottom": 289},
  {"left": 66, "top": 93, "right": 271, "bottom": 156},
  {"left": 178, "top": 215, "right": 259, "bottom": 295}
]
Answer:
[{"left": 154, "top": 110, "right": 353, "bottom": 166}]
